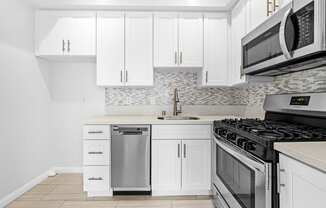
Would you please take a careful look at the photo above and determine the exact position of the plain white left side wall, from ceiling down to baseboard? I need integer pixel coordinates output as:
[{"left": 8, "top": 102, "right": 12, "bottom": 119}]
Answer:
[{"left": 0, "top": 0, "right": 54, "bottom": 203}]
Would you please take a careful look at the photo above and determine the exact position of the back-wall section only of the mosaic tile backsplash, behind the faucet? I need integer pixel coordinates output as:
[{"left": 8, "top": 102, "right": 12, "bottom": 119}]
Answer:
[{"left": 105, "top": 71, "right": 245, "bottom": 106}]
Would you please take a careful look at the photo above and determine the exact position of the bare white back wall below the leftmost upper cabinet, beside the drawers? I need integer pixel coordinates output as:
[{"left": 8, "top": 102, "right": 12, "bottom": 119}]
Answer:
[{"left": 49, "top": 62, "right": 105, "bottom": 167}]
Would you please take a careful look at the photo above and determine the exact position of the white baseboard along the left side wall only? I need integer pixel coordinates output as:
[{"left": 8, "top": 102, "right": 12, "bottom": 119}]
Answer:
[{"left": 0, "top": 171, "right": 49, "bottom": 207}]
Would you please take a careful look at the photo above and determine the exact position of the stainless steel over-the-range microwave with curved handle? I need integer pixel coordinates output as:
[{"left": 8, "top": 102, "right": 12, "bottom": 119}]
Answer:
[{"left": 242, "top": 0, "right": 326, "bottom": 76}]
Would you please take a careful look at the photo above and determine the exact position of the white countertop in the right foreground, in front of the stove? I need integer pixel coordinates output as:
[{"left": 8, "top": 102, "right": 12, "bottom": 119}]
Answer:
[{"left": 274, "top": 142, "right": 326, "bottom": 172}]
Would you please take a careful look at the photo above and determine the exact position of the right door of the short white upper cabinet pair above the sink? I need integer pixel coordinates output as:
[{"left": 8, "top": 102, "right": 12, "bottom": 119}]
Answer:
[{"left": 179, "top": 13, "right": 204, "bottom": 67}]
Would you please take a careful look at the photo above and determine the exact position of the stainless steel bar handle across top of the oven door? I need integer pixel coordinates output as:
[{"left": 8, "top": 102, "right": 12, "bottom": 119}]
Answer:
[{"left": 214, "top": 138, "right": 268, "bottom": 173}]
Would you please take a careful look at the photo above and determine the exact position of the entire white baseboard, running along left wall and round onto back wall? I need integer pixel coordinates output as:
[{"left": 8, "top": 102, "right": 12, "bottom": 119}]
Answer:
[{"left": 0, "top": 167, "right": 83, "bottom": 208}]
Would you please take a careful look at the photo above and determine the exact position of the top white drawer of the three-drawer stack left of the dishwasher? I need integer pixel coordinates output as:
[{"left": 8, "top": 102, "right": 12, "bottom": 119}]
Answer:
[{"left": 83, "top": 125, "right": 111, "bottom": 139}]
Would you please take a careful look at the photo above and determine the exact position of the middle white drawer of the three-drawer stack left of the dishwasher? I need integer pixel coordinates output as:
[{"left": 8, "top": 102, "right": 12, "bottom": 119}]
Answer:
[{"left": 84, "top": 140, "right": 111, "bottom": 165}]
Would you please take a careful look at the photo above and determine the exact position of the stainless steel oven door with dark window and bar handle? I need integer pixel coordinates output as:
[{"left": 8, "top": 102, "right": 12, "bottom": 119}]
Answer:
[{"left": 213, "top": 138, "right": 272, "bottom": 208}]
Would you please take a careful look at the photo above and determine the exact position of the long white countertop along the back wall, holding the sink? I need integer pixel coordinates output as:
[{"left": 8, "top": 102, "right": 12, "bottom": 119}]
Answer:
[{"left": 85, "top": 115, "right": 236, "bottom": 124}]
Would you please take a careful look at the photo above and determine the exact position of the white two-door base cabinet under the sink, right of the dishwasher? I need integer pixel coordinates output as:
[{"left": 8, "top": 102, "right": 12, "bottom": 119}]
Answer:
[{"left": 152, "top": 125, "right": 211, "bottom": 195}]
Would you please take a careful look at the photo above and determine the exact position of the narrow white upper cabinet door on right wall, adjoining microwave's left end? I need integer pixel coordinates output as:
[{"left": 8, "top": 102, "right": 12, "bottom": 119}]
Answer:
[{"left": 229, "top": 0, "right": 248, "bottom": 84}]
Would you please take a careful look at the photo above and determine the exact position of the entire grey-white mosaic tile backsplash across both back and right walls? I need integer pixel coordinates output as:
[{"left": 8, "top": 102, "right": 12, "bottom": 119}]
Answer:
[{"left": 105, "top": 68, "right": 326, "bottom": 107}]
